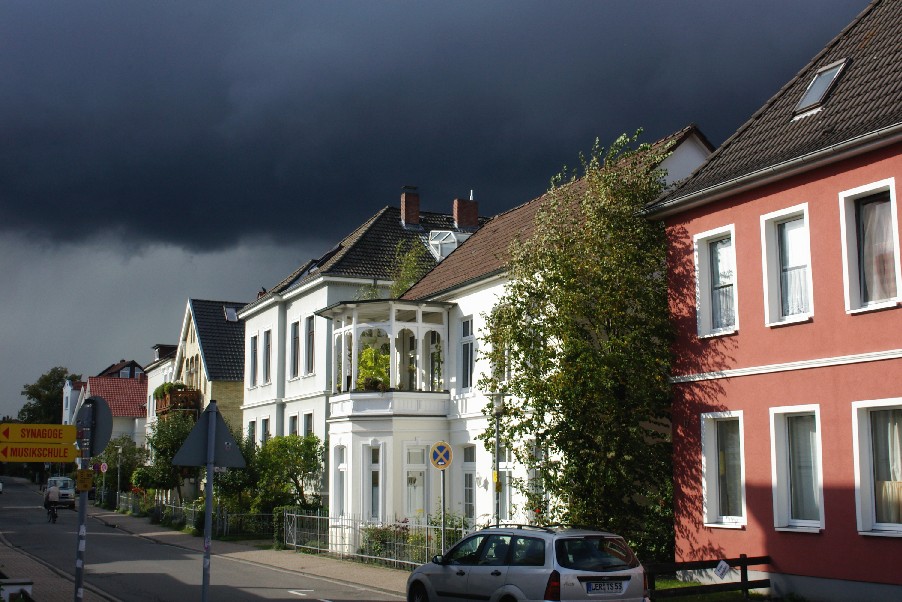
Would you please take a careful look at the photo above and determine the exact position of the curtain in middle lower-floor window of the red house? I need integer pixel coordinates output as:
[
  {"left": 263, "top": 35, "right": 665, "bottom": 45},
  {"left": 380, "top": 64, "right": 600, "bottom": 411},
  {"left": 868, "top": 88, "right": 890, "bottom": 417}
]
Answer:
[{"left": 786, "top": 414, "right": 820, "bottom": 520}]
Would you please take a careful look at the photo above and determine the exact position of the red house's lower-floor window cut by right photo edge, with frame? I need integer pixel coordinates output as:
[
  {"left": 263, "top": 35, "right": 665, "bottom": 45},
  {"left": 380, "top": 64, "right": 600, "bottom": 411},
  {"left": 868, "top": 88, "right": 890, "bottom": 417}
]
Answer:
[{"left": 852, "top": 399, "right": 902, "bottom": 537}]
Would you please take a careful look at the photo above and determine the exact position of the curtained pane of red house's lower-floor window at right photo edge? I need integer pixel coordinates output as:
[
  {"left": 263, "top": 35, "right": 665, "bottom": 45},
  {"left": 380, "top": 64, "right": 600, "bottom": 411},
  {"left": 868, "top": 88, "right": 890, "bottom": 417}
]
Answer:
[{"left": 871, "top": 409, "right": 902, "bottom": 523}]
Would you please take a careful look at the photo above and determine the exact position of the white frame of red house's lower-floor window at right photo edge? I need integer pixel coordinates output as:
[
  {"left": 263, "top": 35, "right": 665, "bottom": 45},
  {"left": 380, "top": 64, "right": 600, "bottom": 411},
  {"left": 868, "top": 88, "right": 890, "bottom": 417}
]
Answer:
[{"left": 852, "top": 397, "right": 902, "bottom": 537}]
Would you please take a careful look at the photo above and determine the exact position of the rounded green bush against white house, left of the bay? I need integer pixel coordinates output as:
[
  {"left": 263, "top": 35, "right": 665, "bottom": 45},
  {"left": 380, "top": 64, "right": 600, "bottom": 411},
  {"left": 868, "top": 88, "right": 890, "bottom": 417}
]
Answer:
[{"left": 254, "top": 435, "right": 325, "bottom": 512}]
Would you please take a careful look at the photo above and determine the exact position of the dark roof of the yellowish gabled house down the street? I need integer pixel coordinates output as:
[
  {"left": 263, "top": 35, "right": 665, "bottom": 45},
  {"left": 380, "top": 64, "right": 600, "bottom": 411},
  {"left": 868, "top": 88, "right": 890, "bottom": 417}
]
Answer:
[{"left": 188, "top": 299, "right": 246, "bottom": 382}]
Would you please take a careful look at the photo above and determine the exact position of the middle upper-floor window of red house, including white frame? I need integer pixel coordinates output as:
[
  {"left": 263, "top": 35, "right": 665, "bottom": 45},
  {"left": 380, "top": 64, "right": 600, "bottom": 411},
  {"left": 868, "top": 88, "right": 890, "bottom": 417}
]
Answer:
[{"left": 761, "top": 205, "right": 813, "bottom": 325}]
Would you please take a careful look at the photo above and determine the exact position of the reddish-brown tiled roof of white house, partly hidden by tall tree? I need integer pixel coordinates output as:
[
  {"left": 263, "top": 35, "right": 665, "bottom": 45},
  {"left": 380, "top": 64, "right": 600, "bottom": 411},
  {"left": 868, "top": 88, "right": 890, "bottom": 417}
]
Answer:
[{"left": 401, "top": 124, "right": 710, "bottom": 300}]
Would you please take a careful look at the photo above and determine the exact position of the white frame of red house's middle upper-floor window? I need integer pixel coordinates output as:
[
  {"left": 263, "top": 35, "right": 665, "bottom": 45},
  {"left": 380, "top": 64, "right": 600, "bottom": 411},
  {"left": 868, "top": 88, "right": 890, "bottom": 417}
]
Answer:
[{"left": 761, "top": 203, "right": 814, "bottom": 326}]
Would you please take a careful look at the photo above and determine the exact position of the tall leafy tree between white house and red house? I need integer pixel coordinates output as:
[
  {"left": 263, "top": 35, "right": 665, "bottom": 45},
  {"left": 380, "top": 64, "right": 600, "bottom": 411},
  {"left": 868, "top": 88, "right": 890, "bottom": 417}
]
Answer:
[{"left": 479, "top": 134, "right": 673, "bottom": 558}]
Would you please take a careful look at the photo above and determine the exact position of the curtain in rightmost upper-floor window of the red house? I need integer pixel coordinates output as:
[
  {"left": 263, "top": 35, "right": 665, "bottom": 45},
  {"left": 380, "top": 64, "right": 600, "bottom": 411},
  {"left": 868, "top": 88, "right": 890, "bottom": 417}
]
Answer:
[{"left": 858, "top": 193, "right": 896, "bottom": 303}]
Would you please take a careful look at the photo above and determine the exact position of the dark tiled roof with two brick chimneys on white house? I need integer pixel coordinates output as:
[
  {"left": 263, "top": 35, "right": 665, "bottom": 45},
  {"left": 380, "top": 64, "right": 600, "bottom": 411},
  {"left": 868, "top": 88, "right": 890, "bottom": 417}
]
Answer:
[{"left": 244, "top": 207, "right": 487, "bottom": 311}]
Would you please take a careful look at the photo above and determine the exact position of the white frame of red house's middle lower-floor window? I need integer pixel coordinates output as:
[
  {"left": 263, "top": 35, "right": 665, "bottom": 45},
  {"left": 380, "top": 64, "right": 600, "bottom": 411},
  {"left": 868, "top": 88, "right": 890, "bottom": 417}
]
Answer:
[{"left": 770, "top": 404, "right": 824, "bottom": 532}]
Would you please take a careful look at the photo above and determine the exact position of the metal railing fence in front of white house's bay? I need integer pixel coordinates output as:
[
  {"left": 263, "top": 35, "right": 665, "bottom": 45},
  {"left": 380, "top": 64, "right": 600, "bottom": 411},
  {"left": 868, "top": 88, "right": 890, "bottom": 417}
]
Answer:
[{"left": 285, "top": 512, "right": 473, "bottom": 569}]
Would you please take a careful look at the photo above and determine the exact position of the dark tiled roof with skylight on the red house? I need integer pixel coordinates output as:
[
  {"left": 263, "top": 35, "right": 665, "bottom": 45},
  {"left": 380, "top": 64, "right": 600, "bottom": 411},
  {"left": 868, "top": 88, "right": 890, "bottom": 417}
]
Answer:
[{"left": 650, "top": 0, "right": 902, "bottom": 213}]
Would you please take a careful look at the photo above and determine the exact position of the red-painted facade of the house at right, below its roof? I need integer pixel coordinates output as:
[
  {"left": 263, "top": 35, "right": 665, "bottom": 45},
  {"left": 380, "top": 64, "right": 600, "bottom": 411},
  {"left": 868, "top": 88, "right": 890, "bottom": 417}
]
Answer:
[{"left": 665, "top": 143, "right": 902, "bottom": 585}]
